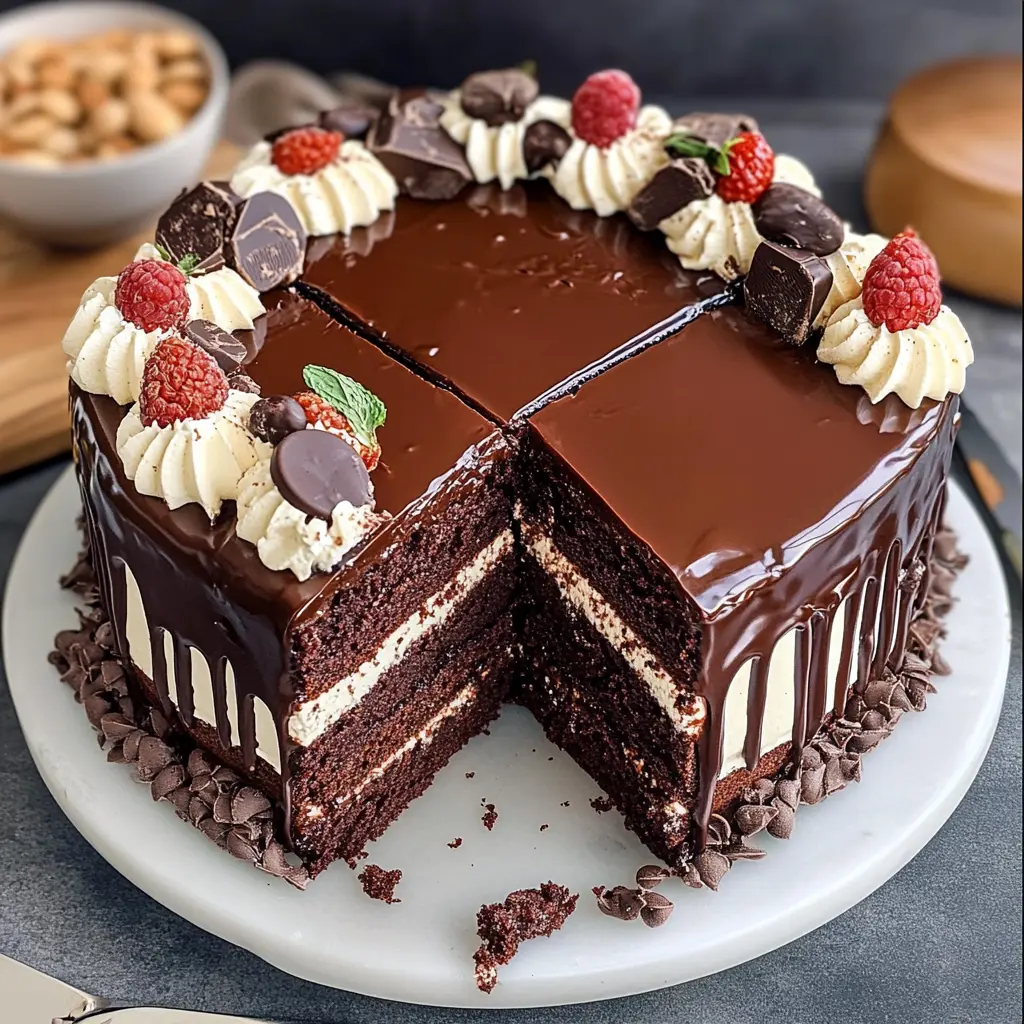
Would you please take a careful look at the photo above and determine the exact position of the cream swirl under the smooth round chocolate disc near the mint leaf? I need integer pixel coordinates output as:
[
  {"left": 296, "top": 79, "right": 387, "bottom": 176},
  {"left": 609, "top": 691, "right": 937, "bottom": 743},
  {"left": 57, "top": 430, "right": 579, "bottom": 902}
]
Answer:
[{"left": 234, "top": 458, "right": 388, "bottom": 580}]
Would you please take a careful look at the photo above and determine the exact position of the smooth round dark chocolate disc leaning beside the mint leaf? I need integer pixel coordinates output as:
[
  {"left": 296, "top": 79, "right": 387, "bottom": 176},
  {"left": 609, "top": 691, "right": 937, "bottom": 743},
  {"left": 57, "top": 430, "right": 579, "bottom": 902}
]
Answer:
[{"left": 270, "top": 430, "right": 371, "bottom": 522}]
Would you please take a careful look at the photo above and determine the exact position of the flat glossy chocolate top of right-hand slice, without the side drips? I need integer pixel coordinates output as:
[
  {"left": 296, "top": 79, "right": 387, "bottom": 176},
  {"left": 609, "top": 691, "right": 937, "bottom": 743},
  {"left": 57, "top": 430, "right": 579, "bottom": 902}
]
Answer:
[{"left": 531, "top": 301, "right": 941, "bottom": 613}]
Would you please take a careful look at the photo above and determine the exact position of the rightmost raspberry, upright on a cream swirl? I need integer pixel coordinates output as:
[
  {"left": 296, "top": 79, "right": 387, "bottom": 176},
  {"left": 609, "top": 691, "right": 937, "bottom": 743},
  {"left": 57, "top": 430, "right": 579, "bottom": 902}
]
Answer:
[{"left": 861, "top": 228, "right": 942, "bottom": 331}]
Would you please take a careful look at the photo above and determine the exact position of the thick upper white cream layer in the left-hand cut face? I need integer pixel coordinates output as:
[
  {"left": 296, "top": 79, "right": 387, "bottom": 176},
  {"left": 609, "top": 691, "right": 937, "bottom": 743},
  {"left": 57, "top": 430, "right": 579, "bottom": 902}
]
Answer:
[{"left": 288, "top": 529, "right": 512, "bottom": 746}]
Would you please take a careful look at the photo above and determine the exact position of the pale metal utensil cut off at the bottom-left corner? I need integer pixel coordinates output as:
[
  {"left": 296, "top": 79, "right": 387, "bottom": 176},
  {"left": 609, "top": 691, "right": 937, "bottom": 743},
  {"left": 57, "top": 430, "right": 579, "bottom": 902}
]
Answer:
[{"left": 0, "top": 953, "right": 269, "bottom": 1024}]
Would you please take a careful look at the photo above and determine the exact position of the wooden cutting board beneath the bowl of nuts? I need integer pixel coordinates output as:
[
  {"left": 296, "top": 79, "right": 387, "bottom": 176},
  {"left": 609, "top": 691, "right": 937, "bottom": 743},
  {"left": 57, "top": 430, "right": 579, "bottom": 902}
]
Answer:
[{"left": 0, "top": 142, "right": 239, "bottom": 473}]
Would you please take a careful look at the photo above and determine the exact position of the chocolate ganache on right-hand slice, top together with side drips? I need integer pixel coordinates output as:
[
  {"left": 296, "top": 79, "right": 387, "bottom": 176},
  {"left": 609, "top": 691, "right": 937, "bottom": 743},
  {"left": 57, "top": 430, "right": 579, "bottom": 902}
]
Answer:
[{"left": 530, "top": 309, "right": 958, "bottom": 848}]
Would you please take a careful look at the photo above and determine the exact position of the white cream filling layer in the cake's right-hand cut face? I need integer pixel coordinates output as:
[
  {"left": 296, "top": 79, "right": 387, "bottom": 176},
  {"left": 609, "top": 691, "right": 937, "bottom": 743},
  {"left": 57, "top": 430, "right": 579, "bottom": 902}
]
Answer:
[{"left": 523, "top": 523, "right": 707, "bottom": 736}]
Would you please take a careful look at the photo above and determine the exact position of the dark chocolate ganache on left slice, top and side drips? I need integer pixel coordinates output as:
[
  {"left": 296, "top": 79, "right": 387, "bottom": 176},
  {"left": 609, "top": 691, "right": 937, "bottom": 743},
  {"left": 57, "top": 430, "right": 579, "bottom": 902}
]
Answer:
[{"left": 72, "top": 294, "right": 495, "bottom": 831}]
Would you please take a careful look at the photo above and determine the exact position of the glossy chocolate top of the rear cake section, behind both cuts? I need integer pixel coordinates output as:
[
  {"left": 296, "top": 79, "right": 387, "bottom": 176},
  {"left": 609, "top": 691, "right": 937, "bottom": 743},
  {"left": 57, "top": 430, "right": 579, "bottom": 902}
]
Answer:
[{"left": 304, "top": 182, "right": 722, "bottom": 419}]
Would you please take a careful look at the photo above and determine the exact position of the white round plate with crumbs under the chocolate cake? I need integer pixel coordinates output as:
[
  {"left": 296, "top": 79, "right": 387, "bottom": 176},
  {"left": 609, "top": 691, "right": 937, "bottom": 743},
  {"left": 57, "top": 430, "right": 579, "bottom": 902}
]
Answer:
[{"left": 3, "top": 470, "right": 1010, "bottom": 1007}]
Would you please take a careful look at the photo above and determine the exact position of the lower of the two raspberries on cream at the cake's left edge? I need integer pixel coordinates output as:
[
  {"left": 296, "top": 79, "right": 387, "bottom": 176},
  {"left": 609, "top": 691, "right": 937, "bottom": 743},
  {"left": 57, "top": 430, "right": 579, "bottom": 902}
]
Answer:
[{"left": 138, "top": 335, "right": 227, "bottom": 427}]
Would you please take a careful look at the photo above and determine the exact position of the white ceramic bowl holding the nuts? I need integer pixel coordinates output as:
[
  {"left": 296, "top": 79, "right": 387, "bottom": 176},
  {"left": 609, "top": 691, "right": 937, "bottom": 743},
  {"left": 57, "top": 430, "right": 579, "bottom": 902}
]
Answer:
[{"left": 0, "top": 2, "right": 229, "bottom": 247}]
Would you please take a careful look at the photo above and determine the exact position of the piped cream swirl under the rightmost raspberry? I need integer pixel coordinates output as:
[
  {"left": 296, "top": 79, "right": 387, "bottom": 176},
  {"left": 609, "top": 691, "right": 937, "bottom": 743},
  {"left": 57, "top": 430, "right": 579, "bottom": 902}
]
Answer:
[{"left": 817, "top": 295, "right": 974, "bottom": 409}]
